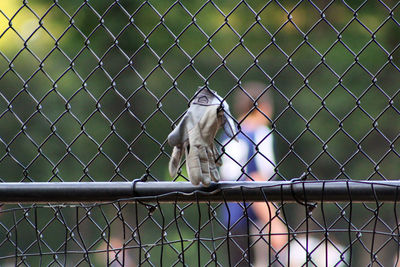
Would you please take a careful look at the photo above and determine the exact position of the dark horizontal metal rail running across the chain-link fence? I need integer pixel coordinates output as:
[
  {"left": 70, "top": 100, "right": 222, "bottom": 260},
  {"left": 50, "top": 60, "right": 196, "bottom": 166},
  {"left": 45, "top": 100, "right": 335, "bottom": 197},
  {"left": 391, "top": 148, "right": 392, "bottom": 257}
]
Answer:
[{"left": 0, "top": 181, "right": 400, "bottom": 203}]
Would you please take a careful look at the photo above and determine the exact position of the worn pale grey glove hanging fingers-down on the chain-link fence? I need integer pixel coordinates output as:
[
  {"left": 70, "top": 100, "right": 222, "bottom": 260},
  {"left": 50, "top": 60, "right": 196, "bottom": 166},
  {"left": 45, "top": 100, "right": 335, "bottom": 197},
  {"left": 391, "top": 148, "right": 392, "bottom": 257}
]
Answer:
[{"left": 168, "top": 88, "right": 236, "bottom": 186}]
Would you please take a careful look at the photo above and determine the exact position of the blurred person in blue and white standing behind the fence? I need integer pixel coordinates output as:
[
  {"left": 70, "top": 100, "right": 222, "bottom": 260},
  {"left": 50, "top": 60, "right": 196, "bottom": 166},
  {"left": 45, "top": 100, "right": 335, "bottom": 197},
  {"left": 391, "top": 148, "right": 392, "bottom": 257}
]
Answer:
[{"left": 220, "top": 82, "right": 288, "bottom": 267}]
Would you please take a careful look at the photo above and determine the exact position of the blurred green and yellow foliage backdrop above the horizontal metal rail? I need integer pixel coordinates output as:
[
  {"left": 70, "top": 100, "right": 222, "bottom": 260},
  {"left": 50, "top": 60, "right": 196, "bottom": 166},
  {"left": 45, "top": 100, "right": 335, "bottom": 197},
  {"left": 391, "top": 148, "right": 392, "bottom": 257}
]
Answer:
[{"left": 0, "top": 0, "right": 400, "bottom": 266}]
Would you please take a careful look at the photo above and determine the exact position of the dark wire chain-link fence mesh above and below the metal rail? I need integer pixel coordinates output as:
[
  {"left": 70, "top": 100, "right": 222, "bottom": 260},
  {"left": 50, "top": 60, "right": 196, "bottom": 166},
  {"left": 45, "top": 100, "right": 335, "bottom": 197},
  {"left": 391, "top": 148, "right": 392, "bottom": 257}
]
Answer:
[{"left": 0, "top": 0, "right": 400, "bottom": 266}]
